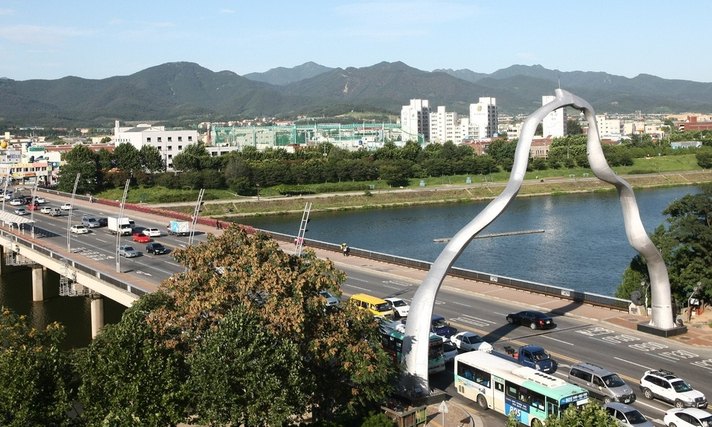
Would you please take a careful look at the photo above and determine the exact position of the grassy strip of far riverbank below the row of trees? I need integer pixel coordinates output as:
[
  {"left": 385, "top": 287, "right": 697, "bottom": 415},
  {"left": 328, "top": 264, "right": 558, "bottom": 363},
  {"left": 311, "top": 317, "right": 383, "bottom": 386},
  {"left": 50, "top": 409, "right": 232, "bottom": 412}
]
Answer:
[{"left": 177, "top": 170, "right": 712, "bottom": 220}]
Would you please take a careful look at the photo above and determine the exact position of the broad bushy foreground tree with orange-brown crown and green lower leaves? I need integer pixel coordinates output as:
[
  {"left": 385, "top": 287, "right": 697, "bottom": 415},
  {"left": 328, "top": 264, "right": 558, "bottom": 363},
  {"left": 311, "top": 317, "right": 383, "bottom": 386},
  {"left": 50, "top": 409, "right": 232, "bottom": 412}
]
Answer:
[{"left": 98, "top": 226, "right": 395, "bottom": 425}]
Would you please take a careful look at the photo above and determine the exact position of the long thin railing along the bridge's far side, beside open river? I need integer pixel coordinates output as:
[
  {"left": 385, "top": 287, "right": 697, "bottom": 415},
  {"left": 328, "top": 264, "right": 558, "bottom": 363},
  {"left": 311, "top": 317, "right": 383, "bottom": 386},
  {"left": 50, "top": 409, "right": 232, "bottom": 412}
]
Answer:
[{"left": 38, "top": 188, "right": 631, "bottom": 312}]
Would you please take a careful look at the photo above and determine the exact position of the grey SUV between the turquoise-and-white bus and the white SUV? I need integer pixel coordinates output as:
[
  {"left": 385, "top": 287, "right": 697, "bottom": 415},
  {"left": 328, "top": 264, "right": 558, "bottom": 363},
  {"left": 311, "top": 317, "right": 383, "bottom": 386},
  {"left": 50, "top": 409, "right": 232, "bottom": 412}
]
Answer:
[{"left": 569, "top": 362, "right": 635, "bottom": 403}]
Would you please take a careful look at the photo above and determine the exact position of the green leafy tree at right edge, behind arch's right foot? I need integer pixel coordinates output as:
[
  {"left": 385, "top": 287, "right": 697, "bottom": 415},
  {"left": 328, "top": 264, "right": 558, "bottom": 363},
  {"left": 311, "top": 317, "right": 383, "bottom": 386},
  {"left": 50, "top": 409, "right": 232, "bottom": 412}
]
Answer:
[{"left": 616, "top": 185, "right": 712, "bottom": 301}]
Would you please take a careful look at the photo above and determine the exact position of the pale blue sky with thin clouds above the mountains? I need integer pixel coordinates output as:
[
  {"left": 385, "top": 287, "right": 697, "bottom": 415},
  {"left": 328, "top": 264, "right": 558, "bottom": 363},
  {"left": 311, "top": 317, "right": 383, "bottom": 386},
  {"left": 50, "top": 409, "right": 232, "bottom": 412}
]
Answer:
[{"left": 0, "top": 0, "right": 712, "bottom": 82}]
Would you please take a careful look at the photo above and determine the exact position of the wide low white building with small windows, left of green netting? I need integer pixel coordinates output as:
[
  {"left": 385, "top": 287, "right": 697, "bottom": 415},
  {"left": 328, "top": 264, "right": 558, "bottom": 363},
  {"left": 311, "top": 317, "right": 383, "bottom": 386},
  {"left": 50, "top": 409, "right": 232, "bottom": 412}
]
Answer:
[{"left": 113, "top": 120, "right": 198, "bottom": 170}]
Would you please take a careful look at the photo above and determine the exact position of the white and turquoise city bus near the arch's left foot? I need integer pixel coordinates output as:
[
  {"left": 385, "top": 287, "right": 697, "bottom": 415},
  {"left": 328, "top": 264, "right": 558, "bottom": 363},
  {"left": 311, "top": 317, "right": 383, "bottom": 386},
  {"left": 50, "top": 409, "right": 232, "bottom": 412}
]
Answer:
[{"left": 453, "top": 351, "right": 588, "bottom": 427}]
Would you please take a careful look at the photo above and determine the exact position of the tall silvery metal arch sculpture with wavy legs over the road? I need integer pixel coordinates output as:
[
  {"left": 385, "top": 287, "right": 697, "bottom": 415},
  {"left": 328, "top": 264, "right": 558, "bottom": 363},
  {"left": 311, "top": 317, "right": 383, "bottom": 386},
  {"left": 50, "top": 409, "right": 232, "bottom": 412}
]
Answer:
[{"left": 402, "top": 89, "right": 675, "bottom": 395}]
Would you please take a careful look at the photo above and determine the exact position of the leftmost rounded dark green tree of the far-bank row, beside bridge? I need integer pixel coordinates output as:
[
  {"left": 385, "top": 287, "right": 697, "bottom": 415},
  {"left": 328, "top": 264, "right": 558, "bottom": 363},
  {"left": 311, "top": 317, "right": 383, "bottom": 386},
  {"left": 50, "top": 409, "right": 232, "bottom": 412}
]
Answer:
[{"left": 57, "top": 144, "right": 99, "bottom": 194}]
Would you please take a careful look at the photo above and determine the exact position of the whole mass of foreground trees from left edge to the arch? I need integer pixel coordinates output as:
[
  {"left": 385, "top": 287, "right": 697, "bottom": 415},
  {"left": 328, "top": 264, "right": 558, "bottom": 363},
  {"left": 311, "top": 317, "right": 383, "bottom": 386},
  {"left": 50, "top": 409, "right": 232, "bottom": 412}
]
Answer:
[{"left": 0, "top": 226, "right": 396, "bottom": 426}]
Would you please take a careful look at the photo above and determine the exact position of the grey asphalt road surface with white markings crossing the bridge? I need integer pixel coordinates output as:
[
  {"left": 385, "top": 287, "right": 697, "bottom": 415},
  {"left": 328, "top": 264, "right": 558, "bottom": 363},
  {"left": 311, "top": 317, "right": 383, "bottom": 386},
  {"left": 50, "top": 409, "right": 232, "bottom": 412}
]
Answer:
[{"left": 5, "top": 193, "right": 712, "bottom": 425}]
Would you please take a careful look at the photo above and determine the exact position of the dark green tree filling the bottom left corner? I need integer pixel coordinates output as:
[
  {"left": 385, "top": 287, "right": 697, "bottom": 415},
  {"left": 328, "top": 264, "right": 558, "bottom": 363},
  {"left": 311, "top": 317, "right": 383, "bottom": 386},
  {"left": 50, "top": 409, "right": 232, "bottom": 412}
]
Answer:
[{"left": 0, "top": 307, "right": 74, "bottom": 427}]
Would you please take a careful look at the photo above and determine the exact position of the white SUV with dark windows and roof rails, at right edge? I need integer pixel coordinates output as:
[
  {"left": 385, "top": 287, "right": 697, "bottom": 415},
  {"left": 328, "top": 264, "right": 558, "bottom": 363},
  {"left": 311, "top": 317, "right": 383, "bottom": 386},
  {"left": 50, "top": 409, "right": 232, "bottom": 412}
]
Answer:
[{"left": 640, "top": 369, "right": 707, "bottom": 408}]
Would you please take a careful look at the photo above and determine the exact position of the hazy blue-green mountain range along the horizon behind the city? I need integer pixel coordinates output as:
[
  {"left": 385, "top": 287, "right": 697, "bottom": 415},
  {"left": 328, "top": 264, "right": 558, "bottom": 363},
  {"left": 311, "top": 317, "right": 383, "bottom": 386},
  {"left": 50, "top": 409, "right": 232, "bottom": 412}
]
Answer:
[{"left": 0, "top": 62, "right": 712, "bottom": 127}]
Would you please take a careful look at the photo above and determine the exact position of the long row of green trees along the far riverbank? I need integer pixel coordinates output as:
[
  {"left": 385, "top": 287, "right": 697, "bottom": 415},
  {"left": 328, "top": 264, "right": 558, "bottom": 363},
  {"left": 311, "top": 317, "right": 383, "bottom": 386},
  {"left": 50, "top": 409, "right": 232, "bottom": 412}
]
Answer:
[{"left": 59, "top": 132, "right": 712, "bottom": 195}]
